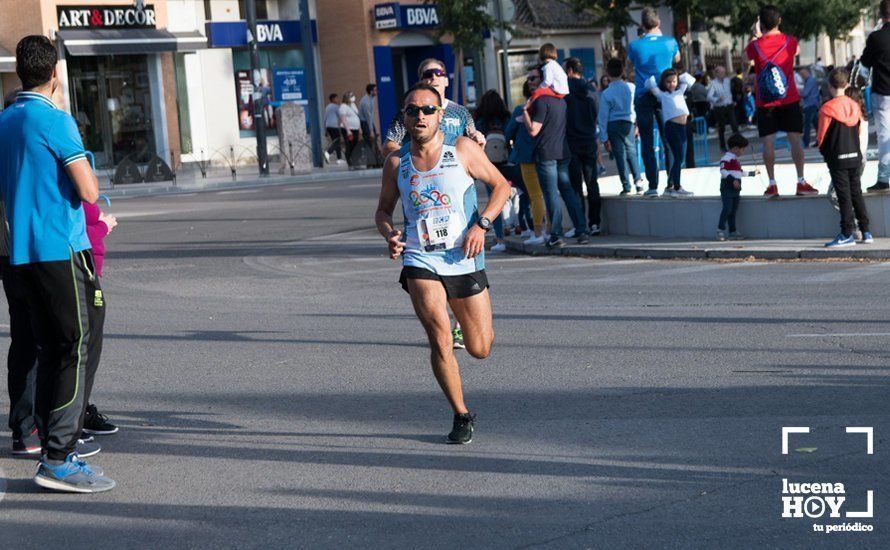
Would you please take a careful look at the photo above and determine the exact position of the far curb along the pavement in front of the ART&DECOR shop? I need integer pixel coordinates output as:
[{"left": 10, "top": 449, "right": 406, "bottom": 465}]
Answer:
[{"left": 99, "top": 168, "right": 382, "bottom": 203}]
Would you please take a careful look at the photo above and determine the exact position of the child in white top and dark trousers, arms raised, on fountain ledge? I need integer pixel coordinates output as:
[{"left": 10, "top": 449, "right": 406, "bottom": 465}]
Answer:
[{"left": 646, "top": 69, "right": 695, "bottom": 197}]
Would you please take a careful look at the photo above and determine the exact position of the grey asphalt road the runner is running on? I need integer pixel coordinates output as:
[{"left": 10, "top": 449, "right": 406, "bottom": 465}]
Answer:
[{"left": 0, "top": 181, "right": 890, "bottom": 549}]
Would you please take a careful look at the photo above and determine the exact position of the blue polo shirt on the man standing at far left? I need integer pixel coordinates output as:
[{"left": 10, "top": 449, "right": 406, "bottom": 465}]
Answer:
[{"left": 0, "top": 92, "right": 90, "bottom": 265}]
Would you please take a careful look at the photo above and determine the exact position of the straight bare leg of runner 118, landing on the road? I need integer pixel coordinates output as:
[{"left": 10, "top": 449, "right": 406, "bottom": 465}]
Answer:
[{"left": 408, "top": 279, "right": 469, "bottom": 414}]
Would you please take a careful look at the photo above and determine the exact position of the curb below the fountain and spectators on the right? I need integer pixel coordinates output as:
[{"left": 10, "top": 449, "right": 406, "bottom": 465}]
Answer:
[{"left": 505, "top": 239, "right": 890, "bottom": 260}]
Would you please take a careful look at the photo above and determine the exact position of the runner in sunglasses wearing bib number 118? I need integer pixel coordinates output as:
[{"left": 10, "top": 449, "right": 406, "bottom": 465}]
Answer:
[{"left": 376, "top": 84, "right": 510, "bottom": 444}]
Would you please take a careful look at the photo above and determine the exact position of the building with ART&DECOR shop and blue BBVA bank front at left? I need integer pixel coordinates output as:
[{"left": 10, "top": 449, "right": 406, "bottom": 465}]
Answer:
[{"left": 0, "top": 0, "right": 320, "bottom": 172}]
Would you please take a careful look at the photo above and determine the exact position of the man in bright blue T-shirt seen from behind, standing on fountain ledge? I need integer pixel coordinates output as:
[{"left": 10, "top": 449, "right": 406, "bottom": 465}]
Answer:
[{"left": 627, "top": 7, "right": 680, "bottom": 197}]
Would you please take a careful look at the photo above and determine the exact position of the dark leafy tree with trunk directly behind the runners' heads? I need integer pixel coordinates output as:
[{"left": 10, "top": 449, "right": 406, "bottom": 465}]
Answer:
[{"left": 423, "top": 0, "right": 510, "bottom": 102}]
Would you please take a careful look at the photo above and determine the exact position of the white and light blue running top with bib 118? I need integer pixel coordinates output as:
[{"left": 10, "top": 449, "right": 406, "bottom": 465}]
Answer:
[{"left": 399, "top": 134, "right": 485, "bottom": 276}]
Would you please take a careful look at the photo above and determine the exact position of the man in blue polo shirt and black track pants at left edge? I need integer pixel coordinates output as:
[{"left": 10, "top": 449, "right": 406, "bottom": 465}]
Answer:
[{"left": 0, "top": 35, "right": 115, "bottom": 493}]
